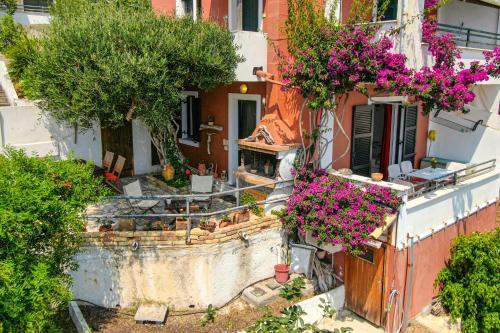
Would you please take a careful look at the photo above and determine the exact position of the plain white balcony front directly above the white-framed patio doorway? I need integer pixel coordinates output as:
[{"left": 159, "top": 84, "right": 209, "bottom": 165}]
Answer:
[{"left": 233, "top": 31, "right": 267, "bottom": 82}]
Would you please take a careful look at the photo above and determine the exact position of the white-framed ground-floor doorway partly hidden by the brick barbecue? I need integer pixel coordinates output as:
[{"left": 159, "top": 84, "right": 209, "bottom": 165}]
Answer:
[{"left": 228, "top": 94, "right": 261, "bottom": 184}]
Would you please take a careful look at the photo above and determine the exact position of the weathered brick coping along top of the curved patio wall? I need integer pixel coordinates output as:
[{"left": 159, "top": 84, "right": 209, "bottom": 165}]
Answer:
[{"left": 82, "top": 216, "right": 281, "bottom": 248}]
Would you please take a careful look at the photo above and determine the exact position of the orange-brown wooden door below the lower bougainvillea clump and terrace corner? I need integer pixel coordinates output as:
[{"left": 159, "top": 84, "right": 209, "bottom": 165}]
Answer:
[{"left": 345, "top": 247, "right": 385, "bottom": 325}]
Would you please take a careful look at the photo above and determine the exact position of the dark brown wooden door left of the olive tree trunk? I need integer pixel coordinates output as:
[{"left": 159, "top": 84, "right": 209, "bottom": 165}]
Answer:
[{"left": 101, "top": 121, "right": 134, "bottom": 176}]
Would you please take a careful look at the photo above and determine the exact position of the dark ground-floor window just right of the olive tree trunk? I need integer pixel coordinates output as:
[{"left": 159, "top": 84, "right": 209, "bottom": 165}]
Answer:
[{"left": 177, "top": 91, "right": 201, "bottom": 146}]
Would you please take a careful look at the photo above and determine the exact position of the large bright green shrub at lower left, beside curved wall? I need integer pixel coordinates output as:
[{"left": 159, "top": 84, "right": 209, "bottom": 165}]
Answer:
[{"left": 0, "top": 148, "right": 108, "bottom": 332}]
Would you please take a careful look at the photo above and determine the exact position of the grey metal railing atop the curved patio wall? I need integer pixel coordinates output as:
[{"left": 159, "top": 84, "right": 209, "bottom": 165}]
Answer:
[{"left": 85, "top": 180, "right": 293, "bottom": 243}]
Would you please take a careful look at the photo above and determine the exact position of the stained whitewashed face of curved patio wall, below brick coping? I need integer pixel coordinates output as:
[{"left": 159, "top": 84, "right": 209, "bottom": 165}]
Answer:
[{"left": 72, "top": 230, "right": 283, "bottom": 310}]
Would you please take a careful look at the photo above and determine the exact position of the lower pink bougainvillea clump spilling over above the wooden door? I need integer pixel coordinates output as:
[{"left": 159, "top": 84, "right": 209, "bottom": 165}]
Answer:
[{"left": 283, "top": 168, "right": 401, "bottom": 254}]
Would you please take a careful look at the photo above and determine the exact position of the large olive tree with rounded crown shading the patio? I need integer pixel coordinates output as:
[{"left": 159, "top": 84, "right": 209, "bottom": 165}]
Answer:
[{"left": 22, "top": 0, "right": 242, "bottom": 163}]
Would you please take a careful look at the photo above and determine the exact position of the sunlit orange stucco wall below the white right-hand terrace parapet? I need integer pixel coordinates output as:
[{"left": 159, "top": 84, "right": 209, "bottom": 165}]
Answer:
[{"left": 383, "top": 203, "right": 498, "bottom": 323}]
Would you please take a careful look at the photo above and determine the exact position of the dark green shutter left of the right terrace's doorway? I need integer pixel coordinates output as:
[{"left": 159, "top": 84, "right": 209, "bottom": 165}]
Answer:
[{"left": 351, "top": 105, "right": 375, "bottom": 176}]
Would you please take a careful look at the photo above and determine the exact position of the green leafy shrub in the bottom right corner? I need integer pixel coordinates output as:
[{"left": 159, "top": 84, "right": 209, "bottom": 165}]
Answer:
[{"left": 436, "top": 228, "right": 500, "bottom": 333}]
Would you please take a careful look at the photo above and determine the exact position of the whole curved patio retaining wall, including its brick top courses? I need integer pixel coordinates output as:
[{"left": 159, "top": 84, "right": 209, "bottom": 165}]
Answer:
[{"left": 71, "top": 217, "right": 286, "bottom": 310}]
